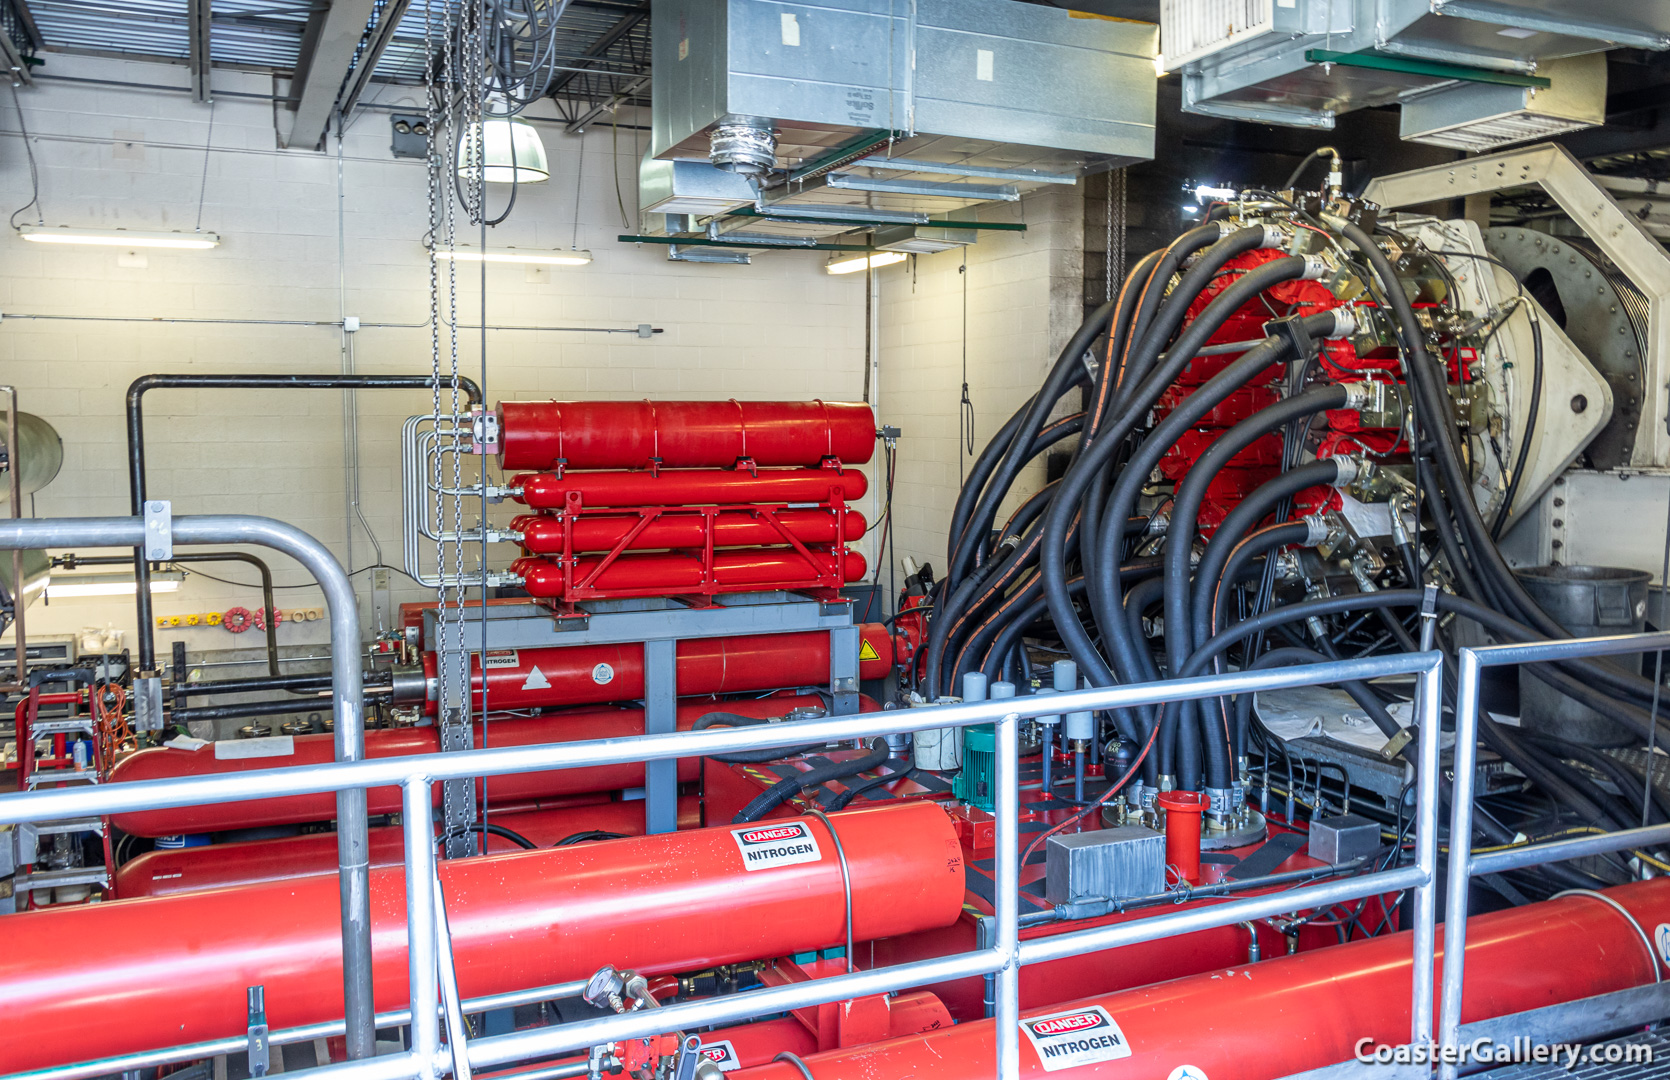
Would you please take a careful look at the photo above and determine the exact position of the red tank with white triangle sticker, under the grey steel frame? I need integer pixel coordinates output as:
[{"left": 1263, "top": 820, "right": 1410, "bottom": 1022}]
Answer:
[{"left": 423, "top": 623, "right": 893, "bottom": 713}]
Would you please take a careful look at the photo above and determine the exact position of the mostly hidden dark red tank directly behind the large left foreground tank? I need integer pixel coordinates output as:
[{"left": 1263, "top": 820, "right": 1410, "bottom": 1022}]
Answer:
[{"left": 115, "top": 795, "right": 701, "bottom": 900}]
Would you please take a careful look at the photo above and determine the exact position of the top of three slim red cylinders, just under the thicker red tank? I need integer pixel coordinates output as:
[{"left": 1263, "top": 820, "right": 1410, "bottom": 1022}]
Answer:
[{"left": 509, "top": 469, "right": 870, "bottom": 511}]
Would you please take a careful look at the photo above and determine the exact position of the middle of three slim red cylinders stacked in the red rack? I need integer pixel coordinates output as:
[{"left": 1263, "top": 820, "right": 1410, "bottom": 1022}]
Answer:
[{"left": 511, "top": 509, "right": 865, "bottom": 554}]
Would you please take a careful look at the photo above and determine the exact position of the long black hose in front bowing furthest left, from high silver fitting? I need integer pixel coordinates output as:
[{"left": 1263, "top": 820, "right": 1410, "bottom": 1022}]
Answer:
[{"left": 1040, "top": 257, "right": 1304, "bottom": 686}]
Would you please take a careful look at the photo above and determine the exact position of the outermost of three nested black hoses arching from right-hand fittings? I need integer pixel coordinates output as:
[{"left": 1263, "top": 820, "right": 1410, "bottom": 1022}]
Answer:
[{"left": 1166, "top": 386, "right": 1348, "bottom": 694}]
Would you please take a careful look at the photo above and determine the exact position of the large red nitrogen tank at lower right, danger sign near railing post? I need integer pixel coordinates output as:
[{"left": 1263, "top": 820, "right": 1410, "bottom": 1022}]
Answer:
[{"left": 735, "top": 878, "right": 1670, "bottom": 1080}]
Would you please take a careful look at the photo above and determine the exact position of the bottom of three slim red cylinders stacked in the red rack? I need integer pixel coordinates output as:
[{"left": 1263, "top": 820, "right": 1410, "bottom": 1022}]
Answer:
[{"left": 511, "top": 548, "right": 865, "bottom": 596}]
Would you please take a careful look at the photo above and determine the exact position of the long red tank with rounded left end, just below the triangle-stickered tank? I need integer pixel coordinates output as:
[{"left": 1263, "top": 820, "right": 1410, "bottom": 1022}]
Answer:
[{"left": 110, "top": 696, "right": 841, "bottom": 836}]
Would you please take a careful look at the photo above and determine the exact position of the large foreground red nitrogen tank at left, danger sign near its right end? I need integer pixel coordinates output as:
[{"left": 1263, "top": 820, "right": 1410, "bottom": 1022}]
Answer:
[{"left": 0, "top": 803, "right": 964, "bottom": 1070}]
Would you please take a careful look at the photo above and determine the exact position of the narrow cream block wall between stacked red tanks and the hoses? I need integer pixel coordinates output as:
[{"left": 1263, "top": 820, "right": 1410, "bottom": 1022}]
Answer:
[{"left": 878, "top": 185, "right": 1084, "bottom": 574}]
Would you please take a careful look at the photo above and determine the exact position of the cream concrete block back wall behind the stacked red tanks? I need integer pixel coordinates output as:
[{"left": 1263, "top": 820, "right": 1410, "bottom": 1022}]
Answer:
[{"left": 0, "top": 55, "right": 872, "bottom": 653}]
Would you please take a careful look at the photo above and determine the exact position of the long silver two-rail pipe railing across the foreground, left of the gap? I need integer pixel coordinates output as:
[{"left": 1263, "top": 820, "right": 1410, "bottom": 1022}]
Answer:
[{"left": 0, "top": 640, "right": 1443, "bottom": 1080}]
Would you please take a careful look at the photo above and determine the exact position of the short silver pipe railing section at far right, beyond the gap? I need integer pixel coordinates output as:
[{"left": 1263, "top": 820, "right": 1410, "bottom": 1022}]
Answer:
[{"left": 1436, "top": 631, "right": 1670, "bottom": 1080}]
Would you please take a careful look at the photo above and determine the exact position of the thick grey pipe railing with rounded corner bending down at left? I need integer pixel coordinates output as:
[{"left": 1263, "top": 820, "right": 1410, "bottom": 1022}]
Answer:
[{"left": 0, "top": 514, "right": 376, "bottom": 1058}]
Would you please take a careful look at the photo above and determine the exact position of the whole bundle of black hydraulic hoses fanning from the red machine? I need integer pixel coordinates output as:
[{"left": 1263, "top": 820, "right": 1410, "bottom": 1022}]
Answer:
[{"left": 919, "top": 209, "right": 1663, "bottom": 880}]
